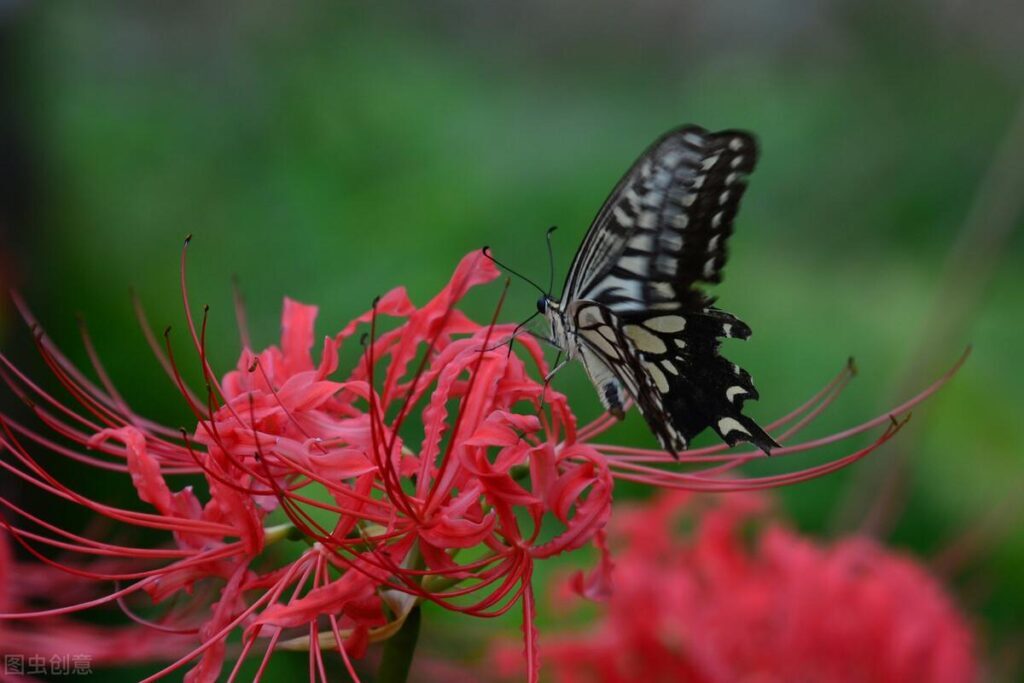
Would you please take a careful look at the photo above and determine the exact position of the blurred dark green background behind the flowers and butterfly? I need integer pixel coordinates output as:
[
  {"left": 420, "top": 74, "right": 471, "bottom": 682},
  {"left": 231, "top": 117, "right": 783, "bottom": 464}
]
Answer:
[{"left": 0, "top": 0, "right": 1024, "bottom": 681}]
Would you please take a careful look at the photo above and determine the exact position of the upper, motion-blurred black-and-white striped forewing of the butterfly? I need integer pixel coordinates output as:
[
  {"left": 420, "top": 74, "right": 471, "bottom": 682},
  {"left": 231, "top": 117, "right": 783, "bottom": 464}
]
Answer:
[{"left": 565, "top": 126, "right": 757, "bottom": 311}]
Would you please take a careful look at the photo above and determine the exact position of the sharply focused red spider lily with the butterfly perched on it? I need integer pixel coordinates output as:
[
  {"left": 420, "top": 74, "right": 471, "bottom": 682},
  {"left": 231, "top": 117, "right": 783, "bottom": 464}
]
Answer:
[{"left": 0, "top": 246, "right": 958, "bottom": 681}]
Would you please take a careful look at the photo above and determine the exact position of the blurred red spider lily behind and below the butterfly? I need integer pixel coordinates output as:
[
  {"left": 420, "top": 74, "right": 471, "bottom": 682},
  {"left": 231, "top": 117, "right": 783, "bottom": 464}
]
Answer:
[{"left": 496, "top": 492, "right": 978, "bottom": 683}]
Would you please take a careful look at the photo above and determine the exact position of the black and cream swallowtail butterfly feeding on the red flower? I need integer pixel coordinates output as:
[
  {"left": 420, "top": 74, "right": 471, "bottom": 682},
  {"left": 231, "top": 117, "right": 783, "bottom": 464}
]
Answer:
[{"left": 538, "top": 125, "right": 778, "bottom": 457}]
